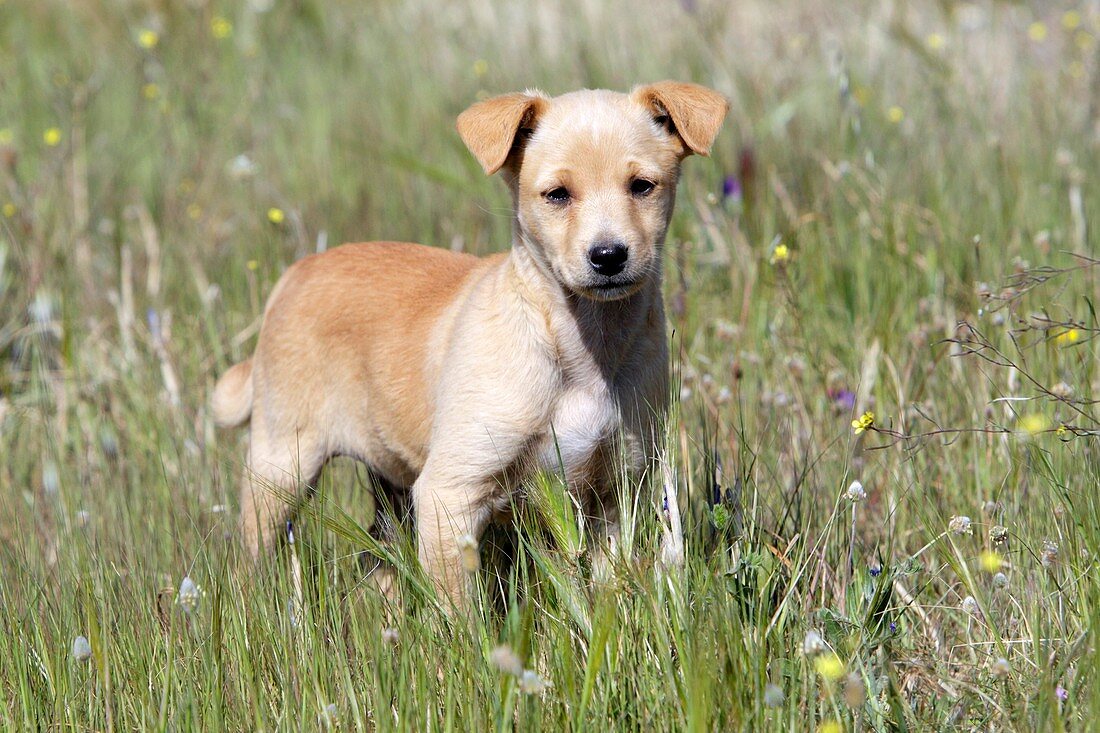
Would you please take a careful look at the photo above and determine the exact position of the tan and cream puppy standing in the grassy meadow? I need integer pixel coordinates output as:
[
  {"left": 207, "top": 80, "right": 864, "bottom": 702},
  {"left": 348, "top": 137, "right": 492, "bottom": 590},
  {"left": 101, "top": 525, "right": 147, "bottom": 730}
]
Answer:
[{"left": 212, "top": 81, "right": 728, "bottom": 603}]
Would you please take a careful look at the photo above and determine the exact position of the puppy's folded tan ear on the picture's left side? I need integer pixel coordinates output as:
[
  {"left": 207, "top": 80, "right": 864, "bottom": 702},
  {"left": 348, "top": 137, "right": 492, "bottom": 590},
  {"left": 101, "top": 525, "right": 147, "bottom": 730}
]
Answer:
[{"left": 455, "top": 92, "right": 547, "bottom": 175}]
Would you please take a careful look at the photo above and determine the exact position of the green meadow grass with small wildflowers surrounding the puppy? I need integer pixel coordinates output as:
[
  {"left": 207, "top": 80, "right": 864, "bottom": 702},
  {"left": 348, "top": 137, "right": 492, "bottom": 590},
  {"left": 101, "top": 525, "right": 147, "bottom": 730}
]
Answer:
[{"left": 0, "top": 0, "right": 1100, "bottom": 731}]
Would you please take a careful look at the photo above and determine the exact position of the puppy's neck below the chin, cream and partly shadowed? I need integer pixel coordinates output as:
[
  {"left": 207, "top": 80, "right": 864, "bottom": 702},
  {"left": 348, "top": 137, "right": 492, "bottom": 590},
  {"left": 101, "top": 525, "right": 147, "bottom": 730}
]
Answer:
[{"left": 508, "top": 236, "right": 664, "bottom": 383}]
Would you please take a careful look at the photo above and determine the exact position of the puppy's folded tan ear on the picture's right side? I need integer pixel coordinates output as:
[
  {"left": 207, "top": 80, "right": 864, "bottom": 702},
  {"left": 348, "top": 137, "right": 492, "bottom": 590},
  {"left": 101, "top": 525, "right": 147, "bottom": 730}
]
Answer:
[{"left": 630, "top": 81, "right": 729, "bottom": 155}]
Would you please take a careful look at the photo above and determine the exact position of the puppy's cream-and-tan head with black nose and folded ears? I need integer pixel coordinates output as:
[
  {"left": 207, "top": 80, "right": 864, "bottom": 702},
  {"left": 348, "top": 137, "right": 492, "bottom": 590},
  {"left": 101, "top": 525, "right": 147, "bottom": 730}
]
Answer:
[{"left": 458, "top": 81, "right": 728, "bottom": 300}]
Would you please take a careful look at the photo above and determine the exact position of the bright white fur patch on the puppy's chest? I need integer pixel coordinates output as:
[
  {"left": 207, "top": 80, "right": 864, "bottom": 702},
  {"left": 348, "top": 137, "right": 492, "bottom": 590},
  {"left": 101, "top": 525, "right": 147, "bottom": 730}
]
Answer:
[{"left": 539, "top": 384, "right": 619, "bottom": 478}]
